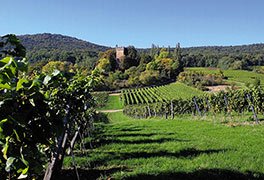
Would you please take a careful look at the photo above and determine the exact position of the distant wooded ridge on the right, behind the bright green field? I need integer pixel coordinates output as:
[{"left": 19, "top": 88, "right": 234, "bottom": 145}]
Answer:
[{"left": 182, "top": 44, "right": 264, "bottom": 70}]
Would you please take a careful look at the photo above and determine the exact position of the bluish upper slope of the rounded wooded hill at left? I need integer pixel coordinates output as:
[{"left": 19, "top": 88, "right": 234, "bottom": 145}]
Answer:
[{"left": 18, "top": 33, "right": 109, "bottom": 52}]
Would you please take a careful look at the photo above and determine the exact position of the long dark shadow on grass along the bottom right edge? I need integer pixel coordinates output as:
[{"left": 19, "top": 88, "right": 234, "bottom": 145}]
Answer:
[{"left": 124, "top": 169, "right": 264, "bottom": 180}]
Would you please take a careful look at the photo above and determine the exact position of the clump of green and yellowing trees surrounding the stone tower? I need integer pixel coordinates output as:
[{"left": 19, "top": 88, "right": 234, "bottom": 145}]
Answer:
[{"left": 96, "top": 46, "right": 182, "bottom": 90}]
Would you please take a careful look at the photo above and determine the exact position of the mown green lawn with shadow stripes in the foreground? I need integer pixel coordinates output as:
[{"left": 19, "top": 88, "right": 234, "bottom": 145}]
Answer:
[{"left": 64, "top": 112, "right": 264, "bottom": 179}]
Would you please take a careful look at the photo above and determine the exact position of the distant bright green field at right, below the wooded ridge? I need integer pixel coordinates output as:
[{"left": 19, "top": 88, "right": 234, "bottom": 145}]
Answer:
[{"left": 186, "top": 67, "right": 264, "bottom": 86}]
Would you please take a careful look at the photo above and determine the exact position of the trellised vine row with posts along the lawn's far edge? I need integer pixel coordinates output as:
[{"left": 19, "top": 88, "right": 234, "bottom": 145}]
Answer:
[{"left": 123, "top": 87, "right": 264, "bottom": 118}]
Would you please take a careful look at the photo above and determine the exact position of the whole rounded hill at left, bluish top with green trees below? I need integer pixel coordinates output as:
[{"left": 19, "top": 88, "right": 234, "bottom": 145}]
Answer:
[{"left": 18, "top": 33, "right": 110, "bottom": 69}]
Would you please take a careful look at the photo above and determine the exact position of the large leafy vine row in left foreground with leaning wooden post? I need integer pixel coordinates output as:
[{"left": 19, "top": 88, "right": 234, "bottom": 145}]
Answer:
[{"left": 0, "top": 35, "right": 99, "bottom": 180}]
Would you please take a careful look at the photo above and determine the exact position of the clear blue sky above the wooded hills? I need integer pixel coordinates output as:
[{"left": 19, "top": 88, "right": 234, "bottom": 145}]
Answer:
[{"left": 0, "top": 0, "right": 264, "bottom": 47}]
